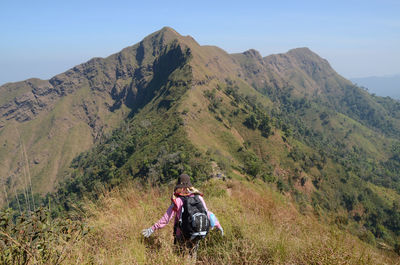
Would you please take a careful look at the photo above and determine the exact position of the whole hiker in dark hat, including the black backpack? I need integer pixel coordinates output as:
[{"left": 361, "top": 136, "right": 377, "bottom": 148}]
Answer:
[{"left": 142, "top": 174, "right": 224, "bottom": 260}]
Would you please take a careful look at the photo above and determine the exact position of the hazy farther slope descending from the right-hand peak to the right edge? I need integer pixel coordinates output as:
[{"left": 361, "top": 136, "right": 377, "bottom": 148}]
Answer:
[{"left": 234, "top": 48, "right": 400, "bottom": 136}]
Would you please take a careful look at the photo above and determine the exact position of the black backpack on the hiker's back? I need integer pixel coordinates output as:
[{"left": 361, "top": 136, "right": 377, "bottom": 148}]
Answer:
[{"left": 179, "top": 195, "right": 210, "bottom": 240}]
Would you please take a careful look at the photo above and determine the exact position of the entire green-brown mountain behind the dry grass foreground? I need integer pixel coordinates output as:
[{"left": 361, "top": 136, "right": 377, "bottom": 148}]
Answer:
[{"left": 0, "top": 27, "right": 400, "bottom": 256}]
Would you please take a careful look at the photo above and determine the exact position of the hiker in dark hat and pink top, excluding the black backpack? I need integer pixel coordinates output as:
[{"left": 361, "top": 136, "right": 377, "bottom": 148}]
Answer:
[{"left": 142, "top": 174, "right": 224, "bottom": 259}]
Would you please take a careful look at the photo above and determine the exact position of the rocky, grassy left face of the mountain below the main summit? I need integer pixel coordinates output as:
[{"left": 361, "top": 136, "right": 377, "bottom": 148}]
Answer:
[{"left": 0, "top": 26, "right": 192, "bottom": 202}]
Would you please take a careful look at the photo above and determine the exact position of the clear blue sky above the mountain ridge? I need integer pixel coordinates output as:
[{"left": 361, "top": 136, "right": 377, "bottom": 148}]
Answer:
[{"left": 0, "top": 0, "right": 400, "bottom": 84}]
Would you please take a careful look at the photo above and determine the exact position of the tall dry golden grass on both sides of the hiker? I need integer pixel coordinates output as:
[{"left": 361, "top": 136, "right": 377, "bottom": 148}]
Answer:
[{"left": 67, "top": 180, "right": 400, "bottom": 264}]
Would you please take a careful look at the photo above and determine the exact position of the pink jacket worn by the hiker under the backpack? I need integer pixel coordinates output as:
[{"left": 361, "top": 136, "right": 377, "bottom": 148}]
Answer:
[{"left": 151, "top": 195, "right": 221, "bottom": 236}]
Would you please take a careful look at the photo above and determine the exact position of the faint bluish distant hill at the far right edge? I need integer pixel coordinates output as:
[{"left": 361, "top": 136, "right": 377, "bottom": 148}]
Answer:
[{"left": 350, "top": 74, "right": 400, "bottom": 99}]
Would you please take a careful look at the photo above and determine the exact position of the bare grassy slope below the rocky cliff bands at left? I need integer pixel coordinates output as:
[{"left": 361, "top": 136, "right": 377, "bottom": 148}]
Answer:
[{"left": 0, "top": 85, "right": 128, "bottom": 204}]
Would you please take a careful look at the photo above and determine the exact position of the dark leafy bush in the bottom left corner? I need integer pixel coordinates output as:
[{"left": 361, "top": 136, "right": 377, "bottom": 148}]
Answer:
[{"left": 0, "top": 208, "right": 87, "bottom": 264}]
